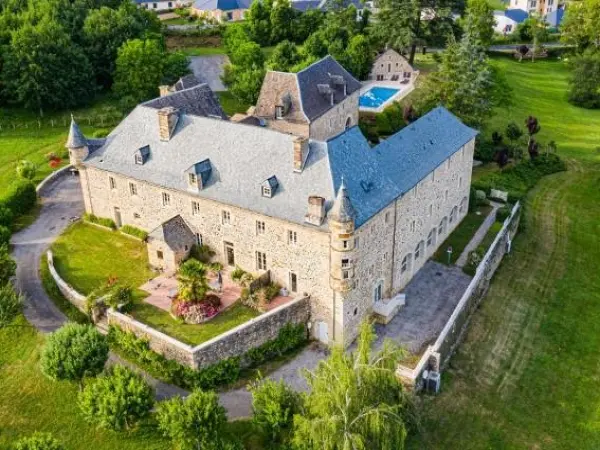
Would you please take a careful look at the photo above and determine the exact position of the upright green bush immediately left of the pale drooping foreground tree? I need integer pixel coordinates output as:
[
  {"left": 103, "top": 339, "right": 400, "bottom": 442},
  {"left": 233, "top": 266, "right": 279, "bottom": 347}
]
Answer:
[{"left": 249, "top": 380, "right": 302, "bottom": 443}]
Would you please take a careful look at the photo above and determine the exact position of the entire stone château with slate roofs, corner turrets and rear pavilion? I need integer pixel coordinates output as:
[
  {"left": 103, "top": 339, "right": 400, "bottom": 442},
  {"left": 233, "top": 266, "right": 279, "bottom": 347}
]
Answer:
[{"left": 67, "top": 56, "right": 476, "bottom": 345}]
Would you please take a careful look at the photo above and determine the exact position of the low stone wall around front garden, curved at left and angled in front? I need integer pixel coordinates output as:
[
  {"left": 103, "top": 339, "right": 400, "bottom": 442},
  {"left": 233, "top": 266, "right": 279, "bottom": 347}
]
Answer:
[{"left": 48, "top": 250, "right": 310, "bottom": 369}]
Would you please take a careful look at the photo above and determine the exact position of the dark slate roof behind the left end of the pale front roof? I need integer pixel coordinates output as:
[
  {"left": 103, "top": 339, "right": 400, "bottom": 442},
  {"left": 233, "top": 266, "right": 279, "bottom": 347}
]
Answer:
[{"left": 143, "top": 83, "right": 227, "bottom": 120}]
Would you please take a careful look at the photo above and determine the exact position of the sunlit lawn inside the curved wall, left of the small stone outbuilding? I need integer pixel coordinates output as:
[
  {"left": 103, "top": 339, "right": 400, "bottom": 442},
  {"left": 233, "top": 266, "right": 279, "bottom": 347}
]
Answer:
[{"left": 52, "top": 222, "right": 155, "bottom": 296}]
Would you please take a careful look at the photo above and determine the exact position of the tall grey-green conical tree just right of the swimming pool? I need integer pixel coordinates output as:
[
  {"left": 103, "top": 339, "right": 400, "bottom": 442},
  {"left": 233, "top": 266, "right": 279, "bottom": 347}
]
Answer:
[{"left": 418, "top": 26, "right": 495, "bottom": 126}]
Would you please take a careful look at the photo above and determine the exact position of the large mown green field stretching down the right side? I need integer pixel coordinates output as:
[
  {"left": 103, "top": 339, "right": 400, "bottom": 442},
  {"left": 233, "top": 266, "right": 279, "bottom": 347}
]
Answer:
[{"left": 408, "top": 59, "right": 600, "bottom": 450}]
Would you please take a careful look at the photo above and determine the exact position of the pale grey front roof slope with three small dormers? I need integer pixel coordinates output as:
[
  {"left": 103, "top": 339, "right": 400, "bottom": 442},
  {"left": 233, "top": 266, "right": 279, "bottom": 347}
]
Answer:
[{"left": 84, "top": 105, "right": 335, "bottom": 229}]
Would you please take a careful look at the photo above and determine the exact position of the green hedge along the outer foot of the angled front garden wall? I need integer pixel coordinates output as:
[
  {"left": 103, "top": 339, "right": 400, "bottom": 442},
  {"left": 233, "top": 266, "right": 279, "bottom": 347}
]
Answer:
[{"left": 108, "top": 323, "right": 307, "bottom": 390}]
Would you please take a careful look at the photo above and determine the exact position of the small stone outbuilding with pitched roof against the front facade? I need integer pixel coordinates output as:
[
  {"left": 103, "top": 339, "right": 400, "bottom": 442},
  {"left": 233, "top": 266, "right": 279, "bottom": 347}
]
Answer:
[{"left": 148, "top": 215, "right": 197, "bottom": 272}]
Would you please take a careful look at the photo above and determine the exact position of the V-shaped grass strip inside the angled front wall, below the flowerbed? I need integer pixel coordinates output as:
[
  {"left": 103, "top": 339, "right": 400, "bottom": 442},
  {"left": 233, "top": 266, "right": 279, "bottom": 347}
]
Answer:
[{"left": 130, "top": 302, "right": 259, "bottom": 345}]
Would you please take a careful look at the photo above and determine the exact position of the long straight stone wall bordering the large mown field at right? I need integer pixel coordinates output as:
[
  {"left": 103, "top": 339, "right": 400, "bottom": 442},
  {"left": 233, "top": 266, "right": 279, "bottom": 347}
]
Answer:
[{"left": 396, "top": 202, "right": 521, "bottom": 390}]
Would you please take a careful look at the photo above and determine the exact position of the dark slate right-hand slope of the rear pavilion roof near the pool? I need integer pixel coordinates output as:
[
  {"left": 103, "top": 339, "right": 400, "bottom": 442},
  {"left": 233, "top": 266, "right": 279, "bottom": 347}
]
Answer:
[{"left": 296, "top": 55, "right": 360, "bottom": 120}]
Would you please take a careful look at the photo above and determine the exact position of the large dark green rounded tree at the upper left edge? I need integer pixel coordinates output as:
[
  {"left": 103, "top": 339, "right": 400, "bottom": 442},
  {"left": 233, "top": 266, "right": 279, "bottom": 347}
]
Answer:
[{"left": 1, "top": 19, "right": 95, "bottom": 115}]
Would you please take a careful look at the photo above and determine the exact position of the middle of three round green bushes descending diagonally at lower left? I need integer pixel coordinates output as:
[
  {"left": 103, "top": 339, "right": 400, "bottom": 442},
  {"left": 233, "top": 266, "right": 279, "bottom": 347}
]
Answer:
[{"left": 79, "top": 366, "right": 154, "bottom": 431}]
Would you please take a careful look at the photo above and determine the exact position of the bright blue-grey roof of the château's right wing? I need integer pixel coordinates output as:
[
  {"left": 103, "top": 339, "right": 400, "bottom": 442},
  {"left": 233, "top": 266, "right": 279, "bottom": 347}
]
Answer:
[{"left": 327, "top": 107, "right": 477, "bottom": 227}]
